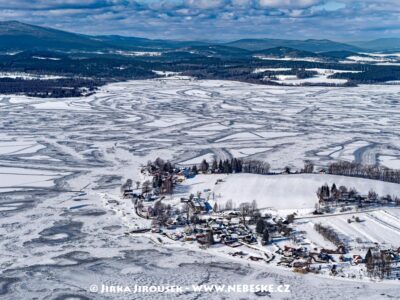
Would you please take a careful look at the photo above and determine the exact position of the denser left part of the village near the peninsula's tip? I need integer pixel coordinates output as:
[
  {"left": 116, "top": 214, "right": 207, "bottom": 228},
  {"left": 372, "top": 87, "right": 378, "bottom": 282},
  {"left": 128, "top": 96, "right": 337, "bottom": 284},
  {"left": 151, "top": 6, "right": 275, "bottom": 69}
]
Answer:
[{"left": 123, "top": 164, "right": 294, "bottom": 251}]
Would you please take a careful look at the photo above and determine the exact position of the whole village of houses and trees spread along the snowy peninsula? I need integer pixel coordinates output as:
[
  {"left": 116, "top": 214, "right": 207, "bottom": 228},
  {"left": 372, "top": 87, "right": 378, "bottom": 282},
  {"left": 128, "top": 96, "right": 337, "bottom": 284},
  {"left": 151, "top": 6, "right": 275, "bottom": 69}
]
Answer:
[{"left": 122, "top": 160, "right": 400, "bottom": 275}]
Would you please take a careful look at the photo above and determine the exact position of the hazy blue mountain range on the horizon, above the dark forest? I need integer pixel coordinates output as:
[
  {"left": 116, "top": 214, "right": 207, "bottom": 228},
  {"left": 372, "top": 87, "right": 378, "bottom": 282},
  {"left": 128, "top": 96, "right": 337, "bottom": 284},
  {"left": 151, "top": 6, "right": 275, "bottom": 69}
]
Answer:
[{"left": 0, "top": 21, "right": 400, "bottom": 56}]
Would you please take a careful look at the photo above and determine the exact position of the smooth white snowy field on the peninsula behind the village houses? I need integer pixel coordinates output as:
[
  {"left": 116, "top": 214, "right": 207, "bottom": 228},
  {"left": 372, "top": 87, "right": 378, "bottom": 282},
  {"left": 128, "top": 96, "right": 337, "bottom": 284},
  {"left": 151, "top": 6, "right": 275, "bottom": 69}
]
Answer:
[{"left": 177, "top": 174, "right": 400, "bottom": 212}]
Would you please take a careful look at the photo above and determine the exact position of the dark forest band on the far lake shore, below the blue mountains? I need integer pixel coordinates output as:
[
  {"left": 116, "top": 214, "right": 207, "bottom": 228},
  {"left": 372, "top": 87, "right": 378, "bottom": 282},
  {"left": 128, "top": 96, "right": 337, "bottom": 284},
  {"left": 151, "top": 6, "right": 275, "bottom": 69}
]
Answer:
[{"left": 0, "top": 49, "right": 400, "bottom": 97}]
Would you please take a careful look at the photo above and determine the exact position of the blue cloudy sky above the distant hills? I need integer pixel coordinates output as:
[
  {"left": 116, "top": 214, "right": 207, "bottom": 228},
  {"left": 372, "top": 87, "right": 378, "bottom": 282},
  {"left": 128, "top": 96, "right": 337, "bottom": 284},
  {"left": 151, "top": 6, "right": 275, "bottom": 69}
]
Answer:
[{"left": 0, "top": 0, "right": 400, "bottom": 41}]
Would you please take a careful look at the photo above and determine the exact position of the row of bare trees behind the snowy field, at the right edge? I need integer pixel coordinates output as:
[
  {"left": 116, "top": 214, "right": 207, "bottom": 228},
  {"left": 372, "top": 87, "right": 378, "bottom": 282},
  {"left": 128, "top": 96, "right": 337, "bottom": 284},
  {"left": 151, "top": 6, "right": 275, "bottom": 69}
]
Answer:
[{"left": 327, "top": 161, "right": 400, "bottom": 183}]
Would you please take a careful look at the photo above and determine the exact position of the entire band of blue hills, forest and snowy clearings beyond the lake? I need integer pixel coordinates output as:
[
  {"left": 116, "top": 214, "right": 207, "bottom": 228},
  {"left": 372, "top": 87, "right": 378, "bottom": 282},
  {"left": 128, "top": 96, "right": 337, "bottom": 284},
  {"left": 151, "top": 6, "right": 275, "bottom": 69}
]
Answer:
[{"left": 0, "top": 22, "right": 400, "bottom": 97}]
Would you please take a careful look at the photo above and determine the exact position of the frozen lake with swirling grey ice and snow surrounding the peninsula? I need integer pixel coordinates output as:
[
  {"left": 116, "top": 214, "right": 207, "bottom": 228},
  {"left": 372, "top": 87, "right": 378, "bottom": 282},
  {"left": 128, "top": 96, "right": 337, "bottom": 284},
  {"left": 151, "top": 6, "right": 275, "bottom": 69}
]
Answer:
[{"left": 0, "top": 77, "right": 400, "bottom": 299}]
